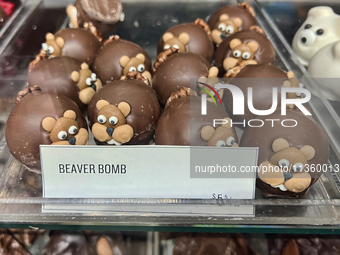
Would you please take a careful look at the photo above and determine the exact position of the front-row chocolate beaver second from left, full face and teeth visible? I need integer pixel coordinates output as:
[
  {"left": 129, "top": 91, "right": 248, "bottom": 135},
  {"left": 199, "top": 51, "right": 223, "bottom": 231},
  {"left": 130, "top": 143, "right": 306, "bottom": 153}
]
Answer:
[{"left": 88, "top": 80, "right": 160, "bottom": 145}]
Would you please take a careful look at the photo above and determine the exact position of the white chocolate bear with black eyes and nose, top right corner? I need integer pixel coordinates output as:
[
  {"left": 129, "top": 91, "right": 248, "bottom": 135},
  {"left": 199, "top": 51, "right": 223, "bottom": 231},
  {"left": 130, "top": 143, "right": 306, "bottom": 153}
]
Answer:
[{"left": 293, "top": 6, "right": 340, "bottom": 66}]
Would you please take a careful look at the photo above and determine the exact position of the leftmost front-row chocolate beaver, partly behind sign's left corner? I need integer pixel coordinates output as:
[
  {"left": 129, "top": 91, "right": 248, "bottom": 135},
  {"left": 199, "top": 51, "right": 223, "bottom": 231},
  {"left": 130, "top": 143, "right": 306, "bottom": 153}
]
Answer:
[{"left": 6, "top": 87, "right": 88, "bottom": 171}]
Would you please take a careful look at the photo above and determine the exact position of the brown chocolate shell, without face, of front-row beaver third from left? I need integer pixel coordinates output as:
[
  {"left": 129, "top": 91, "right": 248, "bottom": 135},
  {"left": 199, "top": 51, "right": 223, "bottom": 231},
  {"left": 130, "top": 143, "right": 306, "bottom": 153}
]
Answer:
[{"left": 155, "top": 96, "right": 238, "bottom": 146}]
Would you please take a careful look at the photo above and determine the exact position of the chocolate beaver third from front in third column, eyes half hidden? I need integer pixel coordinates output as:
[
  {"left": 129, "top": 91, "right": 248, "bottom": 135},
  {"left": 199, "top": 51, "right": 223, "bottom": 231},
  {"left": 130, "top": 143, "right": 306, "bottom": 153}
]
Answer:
[{"left": 157, "top": 23, "right": 214, "bottom": 62}]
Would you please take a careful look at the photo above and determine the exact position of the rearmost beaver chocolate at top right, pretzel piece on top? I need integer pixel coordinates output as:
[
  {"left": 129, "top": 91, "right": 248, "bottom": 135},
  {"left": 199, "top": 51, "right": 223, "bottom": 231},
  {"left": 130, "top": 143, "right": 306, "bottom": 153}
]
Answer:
[{"left": 207, "top": 2, "right": 256, "bottom": 44}]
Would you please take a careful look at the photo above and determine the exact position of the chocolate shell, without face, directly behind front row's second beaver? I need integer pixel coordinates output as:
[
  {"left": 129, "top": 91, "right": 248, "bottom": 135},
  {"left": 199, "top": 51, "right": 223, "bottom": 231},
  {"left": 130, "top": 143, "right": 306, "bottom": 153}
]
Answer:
[{"left": 93, "top": 39, "right": 151, "bottom": 84}]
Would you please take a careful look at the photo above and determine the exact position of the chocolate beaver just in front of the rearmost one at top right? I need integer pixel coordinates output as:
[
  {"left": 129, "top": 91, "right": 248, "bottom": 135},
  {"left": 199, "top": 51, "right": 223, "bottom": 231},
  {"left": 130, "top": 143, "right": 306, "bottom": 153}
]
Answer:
[{"left": 215, "top": 30, "right": 276, "bottom": 76}]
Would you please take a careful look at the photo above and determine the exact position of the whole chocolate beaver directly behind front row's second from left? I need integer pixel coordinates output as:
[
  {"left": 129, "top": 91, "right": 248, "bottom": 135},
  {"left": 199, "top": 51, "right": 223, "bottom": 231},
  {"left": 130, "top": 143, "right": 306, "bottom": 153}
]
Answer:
[{"left": 93, "top": 36, "right": 151, "bottom": 84}]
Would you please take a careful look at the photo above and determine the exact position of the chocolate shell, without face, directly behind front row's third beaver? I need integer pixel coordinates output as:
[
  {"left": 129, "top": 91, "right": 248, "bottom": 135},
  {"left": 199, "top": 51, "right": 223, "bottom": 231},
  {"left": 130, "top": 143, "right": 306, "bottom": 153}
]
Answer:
[{"left": 152, "top": 52, "right": 211, "bottom": 105}]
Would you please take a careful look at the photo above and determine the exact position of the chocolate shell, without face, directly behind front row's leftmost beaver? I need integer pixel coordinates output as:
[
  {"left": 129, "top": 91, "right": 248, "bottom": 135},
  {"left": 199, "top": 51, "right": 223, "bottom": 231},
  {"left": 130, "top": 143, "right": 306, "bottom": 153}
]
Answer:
[{"left": 27, "top": 56, "right": 85, "bottom": 111}]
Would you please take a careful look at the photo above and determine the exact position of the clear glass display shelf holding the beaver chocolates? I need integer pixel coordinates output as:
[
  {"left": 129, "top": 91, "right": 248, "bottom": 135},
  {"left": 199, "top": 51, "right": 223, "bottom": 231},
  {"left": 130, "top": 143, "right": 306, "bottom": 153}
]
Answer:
[{"left": 0, "top": 0, "right": 340, "bottom": 234}]
